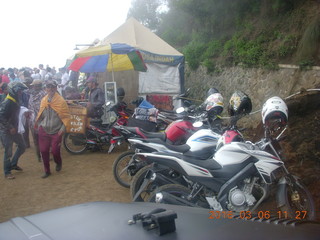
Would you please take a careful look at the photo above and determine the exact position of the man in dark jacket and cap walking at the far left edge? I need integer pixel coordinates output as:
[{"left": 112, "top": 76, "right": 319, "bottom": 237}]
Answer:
[{"left": 0, "top": 81, "right": 27, "bottom": 179}]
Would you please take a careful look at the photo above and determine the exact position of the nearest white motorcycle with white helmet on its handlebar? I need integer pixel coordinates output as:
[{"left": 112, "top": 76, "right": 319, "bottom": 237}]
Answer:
[{"left": 132, "top": 97, "right": 315, "bottom": 220}]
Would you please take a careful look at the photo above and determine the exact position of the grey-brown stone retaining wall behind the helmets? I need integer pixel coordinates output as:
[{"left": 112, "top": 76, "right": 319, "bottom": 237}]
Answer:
[{"left": 185, "top": 65, "right": 320, "bottom": 125}]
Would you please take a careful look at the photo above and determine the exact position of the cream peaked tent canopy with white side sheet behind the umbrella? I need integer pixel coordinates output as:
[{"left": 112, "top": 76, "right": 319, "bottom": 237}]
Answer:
[{"left": 99, "top": 18, "right": 184, "bottom": 94}]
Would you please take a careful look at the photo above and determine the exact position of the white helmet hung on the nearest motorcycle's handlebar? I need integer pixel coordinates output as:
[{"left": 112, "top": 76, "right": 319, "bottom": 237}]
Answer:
[{"left": 261, "top": 97, "right": 288, "bottom": 125}]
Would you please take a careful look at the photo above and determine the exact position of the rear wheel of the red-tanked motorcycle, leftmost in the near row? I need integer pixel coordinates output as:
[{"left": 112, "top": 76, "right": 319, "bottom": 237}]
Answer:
[{"left": 112, "top": 151, "right": 145, "bottom": 188}]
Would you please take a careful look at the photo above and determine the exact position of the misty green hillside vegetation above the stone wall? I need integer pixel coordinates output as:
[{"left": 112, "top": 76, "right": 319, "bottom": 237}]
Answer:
[{"left": 131, "top": 0, "right": 320, "bottom": 68}]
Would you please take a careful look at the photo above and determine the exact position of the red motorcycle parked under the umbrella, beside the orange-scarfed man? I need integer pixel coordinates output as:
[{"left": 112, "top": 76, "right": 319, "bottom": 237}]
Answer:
[{"left": 63, "top": 102, "right": 130, "bottom": 154}]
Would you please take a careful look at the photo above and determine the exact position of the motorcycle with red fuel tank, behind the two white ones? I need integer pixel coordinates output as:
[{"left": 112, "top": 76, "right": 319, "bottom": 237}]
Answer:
[{"left": 112, "top": 107, "right": 209, "bottom": 188}]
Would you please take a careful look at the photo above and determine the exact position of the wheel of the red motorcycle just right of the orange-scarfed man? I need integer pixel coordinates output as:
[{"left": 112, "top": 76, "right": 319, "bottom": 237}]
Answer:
[{"left": 63, "top": 133, "right": 87, "bottom": 154}]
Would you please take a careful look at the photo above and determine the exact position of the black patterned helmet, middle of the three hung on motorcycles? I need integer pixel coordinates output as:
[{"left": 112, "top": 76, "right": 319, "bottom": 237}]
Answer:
[{"left": 228, "top": 91, "right": 252, "bottom": 116}]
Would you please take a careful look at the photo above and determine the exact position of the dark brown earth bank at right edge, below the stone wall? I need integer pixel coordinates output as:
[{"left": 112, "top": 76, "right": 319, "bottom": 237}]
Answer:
[{"left": 253, "top": 88, "right": 320, "bottom": 221}]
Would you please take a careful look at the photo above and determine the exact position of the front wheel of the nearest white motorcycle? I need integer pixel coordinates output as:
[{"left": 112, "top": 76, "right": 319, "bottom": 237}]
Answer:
[{"left": 281, "top": 181, "right": 316, "bottom": 220}]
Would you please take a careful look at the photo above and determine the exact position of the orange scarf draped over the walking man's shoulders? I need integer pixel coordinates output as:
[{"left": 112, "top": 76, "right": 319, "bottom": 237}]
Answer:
[{"left": 36, "top": 92, "right": 71, "bottom": 126}]
